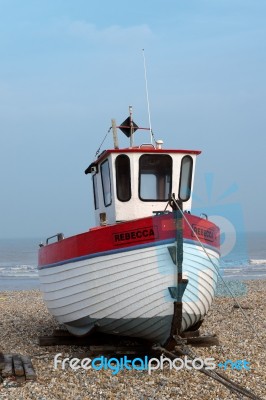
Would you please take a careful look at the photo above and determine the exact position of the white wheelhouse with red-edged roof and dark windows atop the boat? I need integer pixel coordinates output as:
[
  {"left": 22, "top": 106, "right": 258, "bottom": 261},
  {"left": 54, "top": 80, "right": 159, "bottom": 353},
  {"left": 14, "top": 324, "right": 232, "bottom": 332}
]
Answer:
[{"left": 85, "top": 144, "right": 200, "bottom": 225}]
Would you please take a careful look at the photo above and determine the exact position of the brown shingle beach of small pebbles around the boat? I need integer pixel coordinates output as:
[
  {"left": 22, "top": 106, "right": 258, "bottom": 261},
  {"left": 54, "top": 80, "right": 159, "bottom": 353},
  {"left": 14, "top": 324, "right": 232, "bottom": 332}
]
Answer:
[{"left": 0, "top": 280, "right": 266, "bottom": 400}]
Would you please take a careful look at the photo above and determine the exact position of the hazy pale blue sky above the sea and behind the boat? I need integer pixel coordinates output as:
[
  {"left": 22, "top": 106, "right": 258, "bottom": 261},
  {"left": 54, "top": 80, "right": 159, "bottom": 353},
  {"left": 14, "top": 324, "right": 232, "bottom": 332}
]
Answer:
[{"left": 0, "top": 0, "right": 266, "bottom": 238}]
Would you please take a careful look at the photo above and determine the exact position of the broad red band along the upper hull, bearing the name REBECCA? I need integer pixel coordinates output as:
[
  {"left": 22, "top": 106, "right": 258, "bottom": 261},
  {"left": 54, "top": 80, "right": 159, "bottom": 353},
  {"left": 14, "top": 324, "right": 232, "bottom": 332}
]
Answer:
[{"left": 38, "top": 213, "right": 220, "bottom": 268}]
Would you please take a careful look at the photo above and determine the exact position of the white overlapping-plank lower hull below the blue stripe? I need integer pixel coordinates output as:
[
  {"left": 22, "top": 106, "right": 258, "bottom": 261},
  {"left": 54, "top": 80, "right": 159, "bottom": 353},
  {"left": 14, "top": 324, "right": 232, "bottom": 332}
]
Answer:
[{"left": 39, "top": 243, "right": 219, "bottom": 343}]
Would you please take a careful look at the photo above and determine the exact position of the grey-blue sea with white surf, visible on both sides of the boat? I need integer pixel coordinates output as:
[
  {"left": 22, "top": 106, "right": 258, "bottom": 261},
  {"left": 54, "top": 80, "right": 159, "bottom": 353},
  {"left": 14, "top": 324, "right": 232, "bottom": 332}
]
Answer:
[{"left": 0, "top": 232, "right": 266, "bottom": 291}]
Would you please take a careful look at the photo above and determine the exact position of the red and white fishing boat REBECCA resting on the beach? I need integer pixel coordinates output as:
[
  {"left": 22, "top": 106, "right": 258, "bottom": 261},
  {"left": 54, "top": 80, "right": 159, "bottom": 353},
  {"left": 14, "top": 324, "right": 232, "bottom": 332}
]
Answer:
[{"left": 38, "top": 108, "right": 220, "bottom": 345}]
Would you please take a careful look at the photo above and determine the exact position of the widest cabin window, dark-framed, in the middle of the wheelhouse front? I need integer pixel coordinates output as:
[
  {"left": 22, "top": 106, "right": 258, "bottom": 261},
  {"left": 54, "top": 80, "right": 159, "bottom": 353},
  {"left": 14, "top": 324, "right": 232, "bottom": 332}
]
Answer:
[{"left": 139, "top": 154, "right": 172, "bottom": 201}]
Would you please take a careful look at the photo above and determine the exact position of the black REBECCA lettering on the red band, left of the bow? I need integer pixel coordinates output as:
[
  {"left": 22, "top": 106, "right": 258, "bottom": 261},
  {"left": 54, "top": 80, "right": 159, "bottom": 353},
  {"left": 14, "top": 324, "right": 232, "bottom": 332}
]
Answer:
[{"left": 113, "top": 226, "right": 158, "bottom": 245}]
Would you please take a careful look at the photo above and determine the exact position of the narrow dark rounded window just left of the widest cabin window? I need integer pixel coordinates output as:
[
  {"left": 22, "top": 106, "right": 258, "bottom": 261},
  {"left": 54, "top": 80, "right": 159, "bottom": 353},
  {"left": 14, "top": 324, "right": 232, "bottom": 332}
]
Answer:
[{"left": 115, "top": 154, "right": 131, "bottom": 201}]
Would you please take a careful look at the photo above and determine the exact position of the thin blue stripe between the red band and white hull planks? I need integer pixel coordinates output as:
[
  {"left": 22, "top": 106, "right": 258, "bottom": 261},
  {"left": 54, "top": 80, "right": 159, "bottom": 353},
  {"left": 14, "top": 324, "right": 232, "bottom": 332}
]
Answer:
[{"left": 38, "top": 239, "right": 219, "bottom": 270}]
